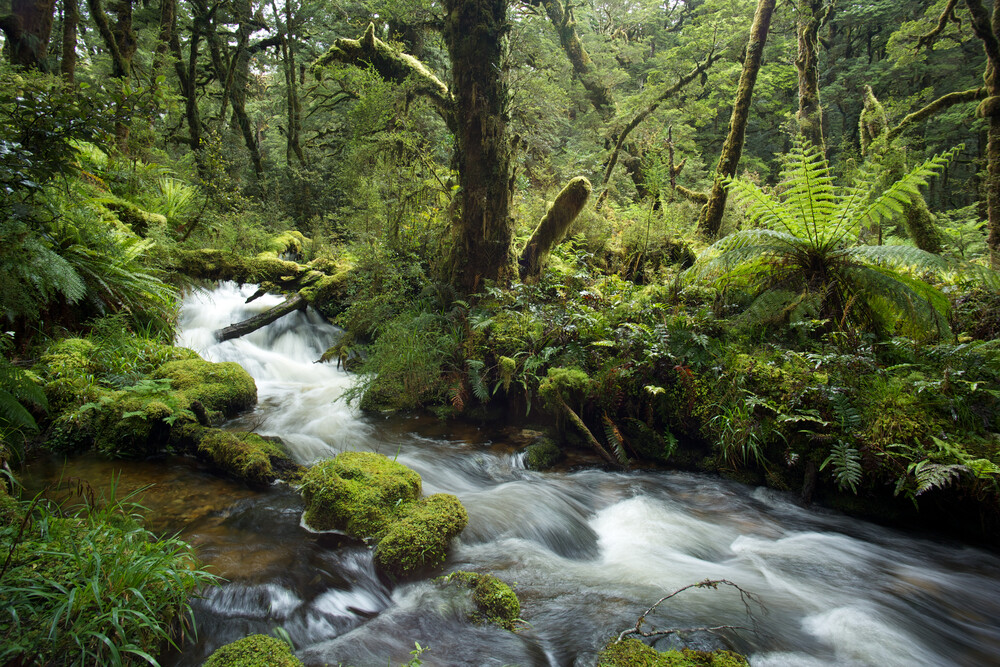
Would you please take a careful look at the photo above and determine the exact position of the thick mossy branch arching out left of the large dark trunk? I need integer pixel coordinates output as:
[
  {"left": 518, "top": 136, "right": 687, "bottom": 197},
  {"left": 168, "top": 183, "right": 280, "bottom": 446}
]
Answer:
[{"left": 312, "top": 23, "right": 455, "bottom": 128}]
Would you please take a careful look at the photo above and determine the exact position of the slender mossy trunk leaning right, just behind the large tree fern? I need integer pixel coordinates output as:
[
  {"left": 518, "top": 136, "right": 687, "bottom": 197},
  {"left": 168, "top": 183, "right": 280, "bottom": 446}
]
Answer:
[{"left": 698, "top": 0, "right": 775, "bottom": 239}]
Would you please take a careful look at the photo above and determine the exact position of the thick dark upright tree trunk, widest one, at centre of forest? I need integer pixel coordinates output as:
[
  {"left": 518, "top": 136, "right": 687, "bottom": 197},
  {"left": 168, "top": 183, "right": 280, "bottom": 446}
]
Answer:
[{"left": 444, "top": 0, "right": 514, "bottom": 293}]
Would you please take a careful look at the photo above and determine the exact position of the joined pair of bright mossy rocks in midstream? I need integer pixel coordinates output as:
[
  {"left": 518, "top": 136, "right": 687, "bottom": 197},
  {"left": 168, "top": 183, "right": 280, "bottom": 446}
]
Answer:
[{"left": 302, "top": 452, "right": 469, "bottom": 577}]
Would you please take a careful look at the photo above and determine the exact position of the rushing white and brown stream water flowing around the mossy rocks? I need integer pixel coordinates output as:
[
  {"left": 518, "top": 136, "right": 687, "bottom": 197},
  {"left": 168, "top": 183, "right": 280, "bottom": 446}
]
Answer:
[{"left": 27, "top": 285, "right": 1000, "bottom": 667}]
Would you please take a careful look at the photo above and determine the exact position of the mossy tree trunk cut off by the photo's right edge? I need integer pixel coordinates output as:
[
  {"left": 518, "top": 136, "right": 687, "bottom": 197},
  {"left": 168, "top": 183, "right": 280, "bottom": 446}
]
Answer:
[{"left": 965, "top": 0, "right": 1000, "bottom": 270}]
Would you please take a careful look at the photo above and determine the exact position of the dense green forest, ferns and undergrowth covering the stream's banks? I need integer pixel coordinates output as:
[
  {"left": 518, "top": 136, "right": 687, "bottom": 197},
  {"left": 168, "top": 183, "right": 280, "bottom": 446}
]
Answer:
[{"left": 0, "top": 0, "right": 1000, "bottom": 662}]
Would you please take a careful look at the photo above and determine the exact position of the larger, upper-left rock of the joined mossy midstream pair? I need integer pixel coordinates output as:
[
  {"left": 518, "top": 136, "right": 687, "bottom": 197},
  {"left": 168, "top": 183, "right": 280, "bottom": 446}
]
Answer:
[{"left": 302, "top": 452, "right": 420, "bottom": 538}]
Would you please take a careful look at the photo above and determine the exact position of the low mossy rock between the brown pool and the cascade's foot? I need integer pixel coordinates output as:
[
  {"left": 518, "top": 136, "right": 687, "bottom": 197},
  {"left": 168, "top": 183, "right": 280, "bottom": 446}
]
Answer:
[{"left": 198, "top": 429, "right": 298, "bottom": 486}]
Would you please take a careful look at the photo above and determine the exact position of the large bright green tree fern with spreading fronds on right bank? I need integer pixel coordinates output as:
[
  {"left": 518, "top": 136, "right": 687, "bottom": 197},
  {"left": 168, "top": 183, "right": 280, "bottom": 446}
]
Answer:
[{"left": 687, "top": 143, "right": 984, "bottom": 335}]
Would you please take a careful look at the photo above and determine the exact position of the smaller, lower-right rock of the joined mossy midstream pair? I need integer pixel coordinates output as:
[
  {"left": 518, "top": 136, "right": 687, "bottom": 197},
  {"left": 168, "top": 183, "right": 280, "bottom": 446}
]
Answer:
[{"left": 375, "top": 493, "right": 469, "bottom": 577}]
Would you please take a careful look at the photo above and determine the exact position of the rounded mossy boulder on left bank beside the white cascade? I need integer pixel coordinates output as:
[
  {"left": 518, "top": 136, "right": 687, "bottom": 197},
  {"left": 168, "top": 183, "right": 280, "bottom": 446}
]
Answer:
[{"left": 153, "top": 358, "right": 257, "bottom": 417}]
